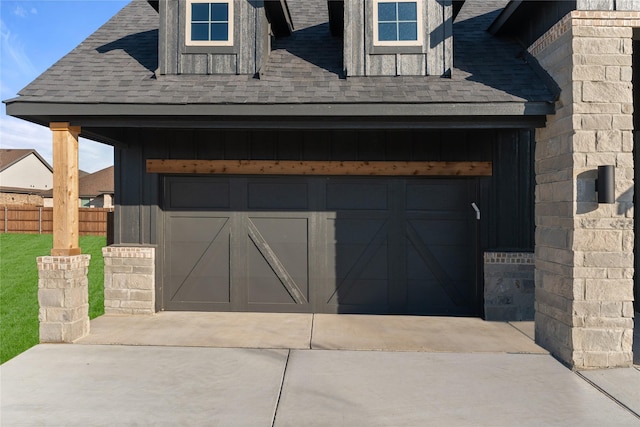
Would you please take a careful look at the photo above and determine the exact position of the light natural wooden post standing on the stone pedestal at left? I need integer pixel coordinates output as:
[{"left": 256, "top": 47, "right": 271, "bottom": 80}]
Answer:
[{"left": 49, "top": 122, "right": 80, "bottom": 256}]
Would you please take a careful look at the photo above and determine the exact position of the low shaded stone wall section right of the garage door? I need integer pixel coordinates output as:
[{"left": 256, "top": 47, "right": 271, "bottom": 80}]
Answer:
[{"left": 484, "top": 252, "right": 535, "bottom": 321}]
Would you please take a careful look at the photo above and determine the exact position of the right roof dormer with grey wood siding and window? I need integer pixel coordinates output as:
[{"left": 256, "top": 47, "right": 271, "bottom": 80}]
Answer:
[{"left": 336, "top": 0, "right": 462, "bottom": 77}]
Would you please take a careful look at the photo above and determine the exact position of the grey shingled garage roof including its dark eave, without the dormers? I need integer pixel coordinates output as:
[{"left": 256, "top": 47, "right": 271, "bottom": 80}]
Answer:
[{"left": 6, "top": 0, "right": 555, "bottom": 127}]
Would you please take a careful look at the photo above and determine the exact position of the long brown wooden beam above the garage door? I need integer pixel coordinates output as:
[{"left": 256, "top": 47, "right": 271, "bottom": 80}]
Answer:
[{"left": 147, "top": 159, "right": 492, "bottom": 176}]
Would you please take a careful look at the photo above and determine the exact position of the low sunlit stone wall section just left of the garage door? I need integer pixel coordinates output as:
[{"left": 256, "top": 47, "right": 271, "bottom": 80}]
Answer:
[{"left": 102, "top": 246, "right": 156, "bottom": 314}]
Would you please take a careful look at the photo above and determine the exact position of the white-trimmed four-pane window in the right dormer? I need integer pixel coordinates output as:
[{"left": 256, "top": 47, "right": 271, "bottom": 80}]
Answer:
[{"left": 373, "top": 0, "right": 424, "bottom": 46}]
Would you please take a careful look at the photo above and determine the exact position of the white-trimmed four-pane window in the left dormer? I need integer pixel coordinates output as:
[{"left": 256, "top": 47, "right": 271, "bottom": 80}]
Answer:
[{"left": 186, "top": 0, "right": 233, "bottom": 46}]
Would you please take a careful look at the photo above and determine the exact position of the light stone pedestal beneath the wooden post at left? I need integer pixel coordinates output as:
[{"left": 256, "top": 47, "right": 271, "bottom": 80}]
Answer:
[{"left": 37, "top": 255, "right": 91, "bottom": 343}]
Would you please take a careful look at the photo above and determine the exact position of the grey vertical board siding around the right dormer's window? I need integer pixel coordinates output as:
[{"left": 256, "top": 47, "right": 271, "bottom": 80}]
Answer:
[{"left": 344, "top": 0, "right": 453, "bottom": 76}]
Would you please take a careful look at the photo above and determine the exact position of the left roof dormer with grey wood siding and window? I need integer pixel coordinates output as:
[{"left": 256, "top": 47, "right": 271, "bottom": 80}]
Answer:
[{"left": 156, "top": 0, "right": 293, "bottom": 75}]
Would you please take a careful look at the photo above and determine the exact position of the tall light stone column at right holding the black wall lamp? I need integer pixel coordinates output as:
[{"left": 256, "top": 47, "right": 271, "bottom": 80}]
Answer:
[{"left": 529, "top": 11, "right": 640, "bottom": 369}]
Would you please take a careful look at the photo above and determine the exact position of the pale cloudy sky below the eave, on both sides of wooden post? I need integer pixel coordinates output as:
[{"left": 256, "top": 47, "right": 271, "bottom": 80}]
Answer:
[{"left": 0, "top": 115, "right": 113, "bottom": 172}]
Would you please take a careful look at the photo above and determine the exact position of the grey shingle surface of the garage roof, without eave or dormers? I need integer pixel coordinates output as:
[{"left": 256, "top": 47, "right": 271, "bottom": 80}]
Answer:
[{"left": 6, "top": 0, "right": 554, "bottom": 110}]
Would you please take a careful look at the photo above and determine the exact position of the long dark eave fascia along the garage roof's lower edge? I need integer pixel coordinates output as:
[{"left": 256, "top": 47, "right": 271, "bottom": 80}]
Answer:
[{"left": 7, "top": 102, "right": 554, "bottom": 139}]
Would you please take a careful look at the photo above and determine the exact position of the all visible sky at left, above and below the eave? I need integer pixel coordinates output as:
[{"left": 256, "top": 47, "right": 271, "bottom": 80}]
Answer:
[{"left": 0, "top": 0, "right": 129, "bottom": 172}]
